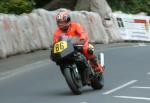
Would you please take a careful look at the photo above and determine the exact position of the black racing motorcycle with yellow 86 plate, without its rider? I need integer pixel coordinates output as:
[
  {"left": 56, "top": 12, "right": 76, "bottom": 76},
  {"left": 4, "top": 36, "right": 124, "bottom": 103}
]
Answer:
[{"left": 50, "top": 36, "right": 104, "bottom": 94}]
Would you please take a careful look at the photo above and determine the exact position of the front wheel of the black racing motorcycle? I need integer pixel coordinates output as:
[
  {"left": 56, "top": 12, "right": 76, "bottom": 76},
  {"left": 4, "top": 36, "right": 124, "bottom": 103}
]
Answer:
[{"left": 64, "top": 68, "right": 82, "bottom": 95}]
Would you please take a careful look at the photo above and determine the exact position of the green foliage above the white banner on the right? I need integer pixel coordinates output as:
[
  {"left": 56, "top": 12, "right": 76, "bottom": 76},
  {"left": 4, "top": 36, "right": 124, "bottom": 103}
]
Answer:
[{"left": 107, "top": 0, "right": 150, "bottom": 15}]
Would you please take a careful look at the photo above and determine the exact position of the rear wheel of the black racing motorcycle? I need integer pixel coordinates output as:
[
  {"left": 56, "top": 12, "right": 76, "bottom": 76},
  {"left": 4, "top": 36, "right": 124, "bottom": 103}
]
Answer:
[{"left": 91, "top": 74, "right": 104, "bottom": 90}]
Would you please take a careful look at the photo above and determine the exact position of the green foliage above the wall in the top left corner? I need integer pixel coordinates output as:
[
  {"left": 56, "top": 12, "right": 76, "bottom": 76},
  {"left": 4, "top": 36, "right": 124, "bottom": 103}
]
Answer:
[{"left": 0, "top": 0, "right": 32, "bottom": 14}]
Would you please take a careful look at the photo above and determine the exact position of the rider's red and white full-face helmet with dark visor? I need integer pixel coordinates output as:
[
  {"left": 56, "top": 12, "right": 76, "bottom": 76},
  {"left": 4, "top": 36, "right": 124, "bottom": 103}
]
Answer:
[{"left": 56, "top": 10, "right": 71, "bottom": 31}]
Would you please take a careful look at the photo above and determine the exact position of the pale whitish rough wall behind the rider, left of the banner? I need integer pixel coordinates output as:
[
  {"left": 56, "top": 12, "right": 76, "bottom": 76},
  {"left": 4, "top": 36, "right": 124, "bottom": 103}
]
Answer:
[{"left": 0, "top": 9, "right": 122, "bottom": 58}]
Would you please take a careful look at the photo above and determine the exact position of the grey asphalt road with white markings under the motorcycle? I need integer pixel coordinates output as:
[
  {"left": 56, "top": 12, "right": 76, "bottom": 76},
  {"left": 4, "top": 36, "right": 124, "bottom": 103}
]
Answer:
[{"left": 0, "top": 44, "right": 150, "bottom": 103}]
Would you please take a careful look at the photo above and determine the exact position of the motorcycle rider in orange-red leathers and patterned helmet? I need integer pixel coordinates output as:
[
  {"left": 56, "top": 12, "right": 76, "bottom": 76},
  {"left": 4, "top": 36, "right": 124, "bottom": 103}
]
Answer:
[{"left": 53, "top": 10, "right": 104, "bottom": 73}]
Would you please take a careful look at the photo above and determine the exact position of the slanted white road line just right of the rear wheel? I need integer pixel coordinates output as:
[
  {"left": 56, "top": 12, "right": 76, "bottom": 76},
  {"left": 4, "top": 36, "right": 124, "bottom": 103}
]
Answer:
[{"left": 103, "top": 80, "right": 137, "bottom": 95}]
